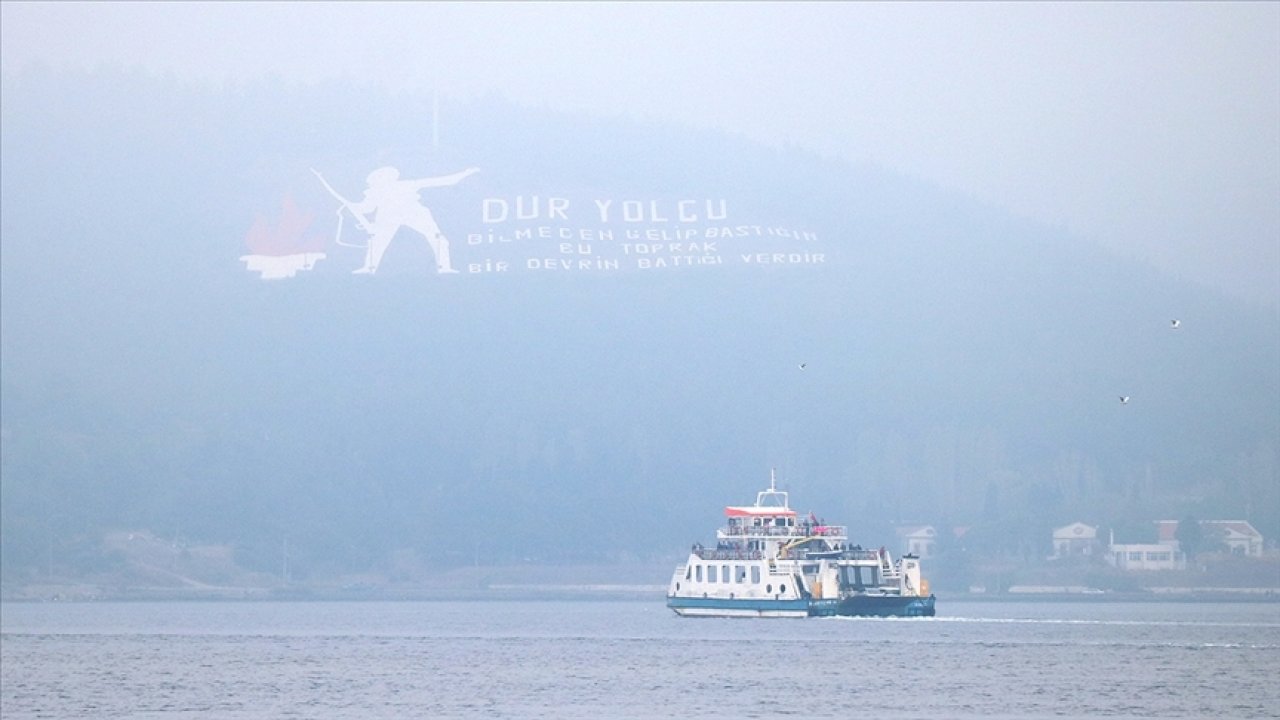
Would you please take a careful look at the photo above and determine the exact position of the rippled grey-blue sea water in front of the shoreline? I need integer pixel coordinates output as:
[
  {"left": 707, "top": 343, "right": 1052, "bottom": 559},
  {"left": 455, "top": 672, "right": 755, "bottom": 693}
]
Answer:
[{"left": 0, "top": 598, "right": 1280, "bottom": 720}]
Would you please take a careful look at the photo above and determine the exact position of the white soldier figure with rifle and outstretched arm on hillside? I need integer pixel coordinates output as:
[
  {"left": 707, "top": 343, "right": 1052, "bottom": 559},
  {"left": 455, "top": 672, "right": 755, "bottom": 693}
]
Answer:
[{"left": 316, "top": 167, "right": 480, "bottom": 274}]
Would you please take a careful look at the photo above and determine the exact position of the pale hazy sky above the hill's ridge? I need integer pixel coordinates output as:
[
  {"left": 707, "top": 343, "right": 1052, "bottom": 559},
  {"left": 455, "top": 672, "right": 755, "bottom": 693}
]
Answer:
[{"left": 0, "top": 1, "right": 1280, "bottom": 309}]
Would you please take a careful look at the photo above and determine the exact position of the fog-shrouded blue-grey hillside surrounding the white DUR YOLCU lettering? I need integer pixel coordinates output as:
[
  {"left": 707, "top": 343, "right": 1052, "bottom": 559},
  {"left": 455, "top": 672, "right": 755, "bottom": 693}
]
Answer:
[{"left": 0, "top": 70, "right": 1280, "bottom": 577}]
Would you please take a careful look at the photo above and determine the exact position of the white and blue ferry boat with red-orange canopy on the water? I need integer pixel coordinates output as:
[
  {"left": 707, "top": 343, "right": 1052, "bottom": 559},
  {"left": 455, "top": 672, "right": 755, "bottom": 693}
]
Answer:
[{"left": 667, "top": 473, "right": 934, "bottom": 618}]
